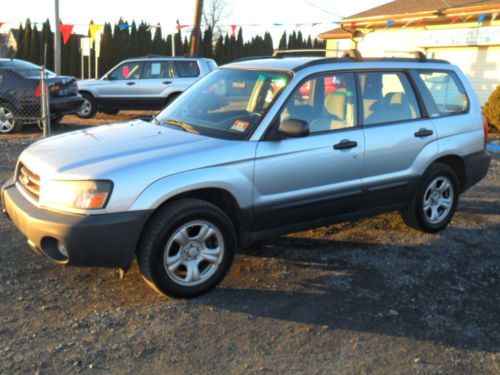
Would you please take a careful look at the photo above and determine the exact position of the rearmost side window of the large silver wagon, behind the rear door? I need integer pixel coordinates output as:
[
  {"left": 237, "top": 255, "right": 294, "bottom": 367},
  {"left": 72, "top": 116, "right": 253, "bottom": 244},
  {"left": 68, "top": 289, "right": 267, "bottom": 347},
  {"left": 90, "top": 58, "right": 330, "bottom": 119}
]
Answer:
[{"left": 419, "top": 70, "right": 469, "bottom": 116}]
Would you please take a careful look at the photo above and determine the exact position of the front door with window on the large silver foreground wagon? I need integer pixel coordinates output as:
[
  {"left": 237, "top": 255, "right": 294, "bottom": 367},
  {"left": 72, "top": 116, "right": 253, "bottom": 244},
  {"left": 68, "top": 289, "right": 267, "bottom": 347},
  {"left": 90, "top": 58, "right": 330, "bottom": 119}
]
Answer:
[{"left": 253, "top": 73, "right": 365, "bottom": 231}]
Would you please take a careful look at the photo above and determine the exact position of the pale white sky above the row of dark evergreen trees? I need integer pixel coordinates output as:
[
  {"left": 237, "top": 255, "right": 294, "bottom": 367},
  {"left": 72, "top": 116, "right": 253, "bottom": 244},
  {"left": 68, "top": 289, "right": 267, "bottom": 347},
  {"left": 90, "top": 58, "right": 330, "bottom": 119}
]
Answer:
[{"left": 0, "top": 0, "right": 388, "bottom": 43}]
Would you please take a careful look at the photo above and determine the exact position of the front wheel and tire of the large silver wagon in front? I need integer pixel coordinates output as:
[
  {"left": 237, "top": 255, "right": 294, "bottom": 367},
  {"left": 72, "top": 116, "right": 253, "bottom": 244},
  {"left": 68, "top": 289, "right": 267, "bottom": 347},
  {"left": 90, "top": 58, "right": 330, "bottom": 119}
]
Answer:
[{"left": 137, "top": 199, "right": 236, "bottom": 298}]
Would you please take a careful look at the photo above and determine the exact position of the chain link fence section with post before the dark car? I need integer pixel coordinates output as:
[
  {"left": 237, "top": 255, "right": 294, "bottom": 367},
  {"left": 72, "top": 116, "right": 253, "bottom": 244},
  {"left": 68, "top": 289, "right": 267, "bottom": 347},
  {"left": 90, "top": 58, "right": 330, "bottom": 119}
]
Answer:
[{"left": 0, "top": 65, "right": 50, "bottom": 136}]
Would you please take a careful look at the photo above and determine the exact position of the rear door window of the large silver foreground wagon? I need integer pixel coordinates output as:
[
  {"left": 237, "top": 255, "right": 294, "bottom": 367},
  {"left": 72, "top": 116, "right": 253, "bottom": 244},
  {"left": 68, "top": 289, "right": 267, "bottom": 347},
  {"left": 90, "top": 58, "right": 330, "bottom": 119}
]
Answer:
[{"left": 359, "top": 72, "right": 420, "bottom": 125}]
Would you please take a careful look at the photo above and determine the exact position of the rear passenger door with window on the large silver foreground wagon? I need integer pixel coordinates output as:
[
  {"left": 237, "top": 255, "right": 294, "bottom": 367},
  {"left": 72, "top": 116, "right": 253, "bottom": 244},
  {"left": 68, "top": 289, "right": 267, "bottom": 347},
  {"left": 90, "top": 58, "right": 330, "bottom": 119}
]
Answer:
[{"left": 358, "top": 71, "right": 438, "bottom": 209}]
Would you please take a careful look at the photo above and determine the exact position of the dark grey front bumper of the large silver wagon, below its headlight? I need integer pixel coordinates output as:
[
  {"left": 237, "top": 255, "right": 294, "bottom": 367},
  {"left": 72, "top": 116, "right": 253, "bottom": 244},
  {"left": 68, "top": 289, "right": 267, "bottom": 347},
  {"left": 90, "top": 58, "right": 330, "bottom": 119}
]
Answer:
[{"left": 1, "top": 180, "right": 150, "bottom": 268}]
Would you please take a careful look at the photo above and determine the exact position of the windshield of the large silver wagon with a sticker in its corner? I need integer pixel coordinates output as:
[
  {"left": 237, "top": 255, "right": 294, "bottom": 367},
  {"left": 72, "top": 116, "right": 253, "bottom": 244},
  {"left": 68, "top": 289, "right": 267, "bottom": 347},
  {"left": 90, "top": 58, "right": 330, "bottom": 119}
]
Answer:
[{"left": 157, "top": 69, "right": 291, "bottom": 139}]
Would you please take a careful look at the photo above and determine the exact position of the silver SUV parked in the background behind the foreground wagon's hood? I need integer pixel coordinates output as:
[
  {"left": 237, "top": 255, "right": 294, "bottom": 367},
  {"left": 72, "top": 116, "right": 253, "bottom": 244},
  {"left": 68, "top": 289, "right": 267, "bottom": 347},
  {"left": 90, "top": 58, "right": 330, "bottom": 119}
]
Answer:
[{"left": 78, "top": 55, "right": 217, "bottom": 118}]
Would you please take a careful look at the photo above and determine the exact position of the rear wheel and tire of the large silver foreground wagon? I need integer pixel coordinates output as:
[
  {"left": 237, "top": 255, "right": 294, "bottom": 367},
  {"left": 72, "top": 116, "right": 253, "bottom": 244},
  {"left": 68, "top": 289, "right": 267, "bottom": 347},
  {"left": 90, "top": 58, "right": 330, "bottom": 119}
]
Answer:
[{"left": 401, "top": 163, "right": 460, "bottom": 233}]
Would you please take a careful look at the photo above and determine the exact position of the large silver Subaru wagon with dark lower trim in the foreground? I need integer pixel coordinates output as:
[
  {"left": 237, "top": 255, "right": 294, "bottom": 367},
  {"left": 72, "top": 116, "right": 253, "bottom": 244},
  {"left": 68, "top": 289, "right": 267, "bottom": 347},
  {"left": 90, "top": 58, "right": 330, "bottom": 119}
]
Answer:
[{"left": 2, "top": 50, "right": 490, "bottom": 297}]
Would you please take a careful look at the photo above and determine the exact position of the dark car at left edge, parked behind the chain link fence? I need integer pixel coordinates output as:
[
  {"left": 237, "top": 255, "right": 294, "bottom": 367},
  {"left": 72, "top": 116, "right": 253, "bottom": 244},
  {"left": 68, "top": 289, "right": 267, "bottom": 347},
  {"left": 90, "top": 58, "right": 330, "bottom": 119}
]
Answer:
[{"left": 0, "top": 59, "right": 83, "bottom": 134}]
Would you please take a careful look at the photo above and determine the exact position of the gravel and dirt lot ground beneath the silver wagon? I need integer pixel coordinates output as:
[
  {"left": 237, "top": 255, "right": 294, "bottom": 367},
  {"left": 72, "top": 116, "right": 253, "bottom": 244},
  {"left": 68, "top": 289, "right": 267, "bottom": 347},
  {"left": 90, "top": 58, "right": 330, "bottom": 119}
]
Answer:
[{"left": 0, "top": 114, "right": 500, "bottom": 374}]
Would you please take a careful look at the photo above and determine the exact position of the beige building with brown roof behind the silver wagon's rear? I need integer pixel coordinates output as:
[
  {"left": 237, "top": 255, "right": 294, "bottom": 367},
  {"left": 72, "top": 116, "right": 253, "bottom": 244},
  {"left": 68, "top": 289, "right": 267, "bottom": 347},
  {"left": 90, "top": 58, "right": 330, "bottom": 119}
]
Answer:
[{"left": 319, "top": 0, "right": 500, "bottom": 103}]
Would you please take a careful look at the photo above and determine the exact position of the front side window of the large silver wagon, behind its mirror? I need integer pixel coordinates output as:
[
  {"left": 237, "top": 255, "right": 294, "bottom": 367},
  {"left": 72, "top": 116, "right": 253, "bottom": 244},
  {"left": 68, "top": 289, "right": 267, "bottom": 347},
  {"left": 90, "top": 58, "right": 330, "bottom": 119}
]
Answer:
[{"left": 280, "top": 73, "right": 356, "bottom": 133}]
